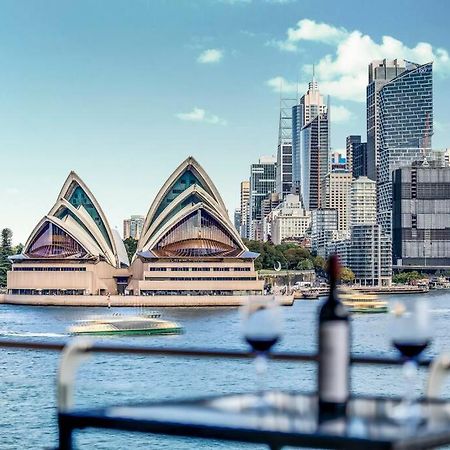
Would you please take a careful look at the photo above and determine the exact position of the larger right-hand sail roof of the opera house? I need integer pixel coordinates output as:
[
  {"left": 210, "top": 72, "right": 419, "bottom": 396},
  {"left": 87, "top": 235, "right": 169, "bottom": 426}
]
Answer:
[{"left": 136, "top": 157, "right": 257, "bottom": 258}]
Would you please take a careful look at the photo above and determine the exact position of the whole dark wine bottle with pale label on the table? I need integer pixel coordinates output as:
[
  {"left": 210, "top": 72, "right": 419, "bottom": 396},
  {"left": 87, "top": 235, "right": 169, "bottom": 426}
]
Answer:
[{"left": 318, "top": 255, "right": 350, "bottom": 418}]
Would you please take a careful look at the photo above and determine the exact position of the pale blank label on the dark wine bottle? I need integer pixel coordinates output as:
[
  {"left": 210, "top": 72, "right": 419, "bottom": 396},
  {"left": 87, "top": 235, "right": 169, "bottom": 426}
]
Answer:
[{"left": 319, "top": 320, "right": 350, "bottom": 403}]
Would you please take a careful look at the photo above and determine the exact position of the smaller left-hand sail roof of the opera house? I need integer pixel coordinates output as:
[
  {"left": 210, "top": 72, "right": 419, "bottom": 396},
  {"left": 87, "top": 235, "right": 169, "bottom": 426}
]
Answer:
[{"left": 14, "top": 172, "right": 129, "bottom": 268}]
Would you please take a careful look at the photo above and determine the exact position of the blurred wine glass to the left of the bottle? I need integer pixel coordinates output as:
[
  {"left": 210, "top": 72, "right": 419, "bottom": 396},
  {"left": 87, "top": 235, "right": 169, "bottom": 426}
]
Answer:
[{"left": 242, "top": 295, "right": 282, "bottom": 407}]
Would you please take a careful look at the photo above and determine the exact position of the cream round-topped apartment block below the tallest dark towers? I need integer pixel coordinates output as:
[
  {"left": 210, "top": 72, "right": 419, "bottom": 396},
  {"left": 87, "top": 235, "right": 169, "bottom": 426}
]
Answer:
[{"left": 350, "top": 177, "right": 377, "bottom": 227}]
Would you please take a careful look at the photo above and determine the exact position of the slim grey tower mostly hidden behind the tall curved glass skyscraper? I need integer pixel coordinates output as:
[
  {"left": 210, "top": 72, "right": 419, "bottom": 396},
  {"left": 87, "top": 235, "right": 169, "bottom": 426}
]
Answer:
[{"left": 366, "top": 59, "right": 406, "bottom": 181}]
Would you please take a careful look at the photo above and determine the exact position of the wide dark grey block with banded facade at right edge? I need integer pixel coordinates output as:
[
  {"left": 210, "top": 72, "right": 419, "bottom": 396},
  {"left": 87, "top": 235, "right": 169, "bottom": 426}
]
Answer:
[{"left": 392, "top": 161, "right": 450, "bottom": 270}]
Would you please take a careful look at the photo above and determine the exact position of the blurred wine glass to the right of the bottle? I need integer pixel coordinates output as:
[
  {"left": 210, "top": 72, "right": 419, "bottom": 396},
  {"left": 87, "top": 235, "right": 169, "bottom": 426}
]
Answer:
[{"left": 390, "top": 298, "right": 432, "bottom": 425}]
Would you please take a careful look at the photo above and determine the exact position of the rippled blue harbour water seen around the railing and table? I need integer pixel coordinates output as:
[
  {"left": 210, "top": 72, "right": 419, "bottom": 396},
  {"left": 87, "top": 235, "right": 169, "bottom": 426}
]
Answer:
[{"left": 0, "top": 291, "right": 450, "bottom": 450}]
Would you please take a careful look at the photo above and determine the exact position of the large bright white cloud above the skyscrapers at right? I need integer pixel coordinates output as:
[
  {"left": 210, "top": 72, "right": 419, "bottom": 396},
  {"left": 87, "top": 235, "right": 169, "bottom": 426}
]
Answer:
[{"left": 272, "top": 19, "right": 450, "bottom": 102}]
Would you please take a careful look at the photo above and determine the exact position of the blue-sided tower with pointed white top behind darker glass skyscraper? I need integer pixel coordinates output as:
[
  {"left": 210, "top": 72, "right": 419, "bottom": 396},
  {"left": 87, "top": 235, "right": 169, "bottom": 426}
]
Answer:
[{"left": 292, "top": 77, "right": 327, "bottom": 193}]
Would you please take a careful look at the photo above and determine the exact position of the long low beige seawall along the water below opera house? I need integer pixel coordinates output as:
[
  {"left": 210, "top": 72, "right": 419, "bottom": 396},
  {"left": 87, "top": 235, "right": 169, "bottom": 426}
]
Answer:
[{"left": 0, "top": 294, "right": 294, "bottom": 308}]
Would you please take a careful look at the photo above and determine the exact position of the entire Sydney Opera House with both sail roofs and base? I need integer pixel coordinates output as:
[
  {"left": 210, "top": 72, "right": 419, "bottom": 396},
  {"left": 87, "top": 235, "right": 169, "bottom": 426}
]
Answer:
[{"left": 7, "top": 157, "right": 263, "bottom": 300}]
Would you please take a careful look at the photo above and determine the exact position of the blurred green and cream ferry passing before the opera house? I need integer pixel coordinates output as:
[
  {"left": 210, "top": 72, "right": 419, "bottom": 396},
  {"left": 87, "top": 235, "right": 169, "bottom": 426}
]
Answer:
[{"left": 68, "top": 312, "right": 183, "bottom": 336}]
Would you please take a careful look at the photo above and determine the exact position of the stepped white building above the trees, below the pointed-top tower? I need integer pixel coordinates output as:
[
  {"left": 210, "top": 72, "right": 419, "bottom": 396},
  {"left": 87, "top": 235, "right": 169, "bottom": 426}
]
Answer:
[{"left": 267, "top": 194, "right": 311, "bottom": 245}]
